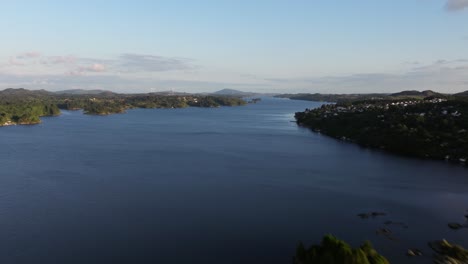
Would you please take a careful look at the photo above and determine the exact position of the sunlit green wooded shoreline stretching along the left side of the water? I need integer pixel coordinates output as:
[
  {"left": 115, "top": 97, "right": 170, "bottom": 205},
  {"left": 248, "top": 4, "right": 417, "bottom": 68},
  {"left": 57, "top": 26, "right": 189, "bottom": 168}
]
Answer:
[{"left": 0, "top": 89, "right": 246, "bottom": 126}]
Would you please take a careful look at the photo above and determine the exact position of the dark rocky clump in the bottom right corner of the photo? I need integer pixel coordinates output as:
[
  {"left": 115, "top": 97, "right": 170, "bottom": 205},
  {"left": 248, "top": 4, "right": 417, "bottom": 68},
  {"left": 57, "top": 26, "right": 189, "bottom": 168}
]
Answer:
[{"left": 429, "top": 239, "right": 468, "bottom": 264}]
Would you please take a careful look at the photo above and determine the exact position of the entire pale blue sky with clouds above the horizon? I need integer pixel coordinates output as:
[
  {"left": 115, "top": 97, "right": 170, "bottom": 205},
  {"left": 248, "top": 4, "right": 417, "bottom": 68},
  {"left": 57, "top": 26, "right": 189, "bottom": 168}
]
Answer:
[{"left": 0, "top": 0, "right": 468, "bottom": 93}]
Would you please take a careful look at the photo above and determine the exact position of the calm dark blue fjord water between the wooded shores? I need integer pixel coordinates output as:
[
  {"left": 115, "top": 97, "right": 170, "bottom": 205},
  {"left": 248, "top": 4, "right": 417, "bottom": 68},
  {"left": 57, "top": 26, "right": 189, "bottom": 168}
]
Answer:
[{"left": 0, "top": 98, "right": 468, "bottom": 263}]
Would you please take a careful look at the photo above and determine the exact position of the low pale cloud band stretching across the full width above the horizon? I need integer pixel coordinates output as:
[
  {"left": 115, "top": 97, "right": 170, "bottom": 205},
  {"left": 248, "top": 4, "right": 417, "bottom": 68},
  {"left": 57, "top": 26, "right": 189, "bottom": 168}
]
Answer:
[{"left": 0, "top": 53, "right": 468, "bottom": 93}]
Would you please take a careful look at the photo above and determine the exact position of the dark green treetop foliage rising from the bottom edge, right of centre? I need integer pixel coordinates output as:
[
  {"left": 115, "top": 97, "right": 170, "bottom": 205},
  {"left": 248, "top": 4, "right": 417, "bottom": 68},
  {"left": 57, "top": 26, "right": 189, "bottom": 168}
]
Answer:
[{"left": 293, "top": 235, "right": 389, "bottom": 264}]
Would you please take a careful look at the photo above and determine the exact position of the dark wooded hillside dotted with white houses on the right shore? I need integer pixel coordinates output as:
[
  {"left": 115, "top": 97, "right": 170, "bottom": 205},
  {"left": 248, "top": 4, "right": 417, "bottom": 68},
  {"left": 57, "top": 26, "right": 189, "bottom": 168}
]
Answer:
[{"left": 295, "top": 92, "right": 468, "bottom": 163}]
